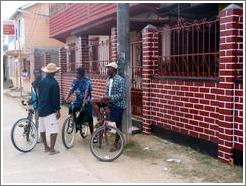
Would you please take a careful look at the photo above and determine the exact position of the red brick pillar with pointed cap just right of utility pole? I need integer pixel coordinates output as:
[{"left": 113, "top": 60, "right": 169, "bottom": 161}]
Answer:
[{"left": 142, "top": 25, "right": 158, "bottom": 134}]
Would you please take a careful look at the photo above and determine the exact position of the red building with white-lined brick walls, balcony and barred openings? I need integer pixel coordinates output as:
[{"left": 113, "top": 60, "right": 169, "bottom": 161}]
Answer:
[{"left": 50, "top": 3, "right": 244, "bottom": 162}]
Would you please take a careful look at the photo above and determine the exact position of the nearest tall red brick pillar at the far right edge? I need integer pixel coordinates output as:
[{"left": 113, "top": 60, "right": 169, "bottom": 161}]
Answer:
[{"left": 217, "top": 4, "right": 243, "bottom": 163}]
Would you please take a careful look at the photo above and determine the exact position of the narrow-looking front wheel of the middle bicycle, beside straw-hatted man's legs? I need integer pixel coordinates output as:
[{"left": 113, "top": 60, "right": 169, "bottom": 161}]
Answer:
[{"left": 62, "top": 116, "right": 76, "bottom": 149}]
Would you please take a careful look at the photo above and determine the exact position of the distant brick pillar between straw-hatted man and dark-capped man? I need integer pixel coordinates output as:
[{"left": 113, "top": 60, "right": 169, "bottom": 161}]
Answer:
[{"left": 57, "top": 48, "right": 67, "bottom": 103}]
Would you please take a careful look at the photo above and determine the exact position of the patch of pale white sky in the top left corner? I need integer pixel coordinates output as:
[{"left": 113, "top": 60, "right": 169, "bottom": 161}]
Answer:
[{"left": 1, "top": 1, "right": 33, "bottom": 20}]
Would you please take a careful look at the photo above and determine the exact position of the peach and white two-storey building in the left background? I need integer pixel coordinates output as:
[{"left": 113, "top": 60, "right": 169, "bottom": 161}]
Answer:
[{"left": 6, "top": 3, "right": 63, "bottom": 91}]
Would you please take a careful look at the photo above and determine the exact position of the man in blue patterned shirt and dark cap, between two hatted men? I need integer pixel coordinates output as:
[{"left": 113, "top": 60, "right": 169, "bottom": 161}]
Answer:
[{"left": 65, "top": 67, "right": 93, "bottom": 134}]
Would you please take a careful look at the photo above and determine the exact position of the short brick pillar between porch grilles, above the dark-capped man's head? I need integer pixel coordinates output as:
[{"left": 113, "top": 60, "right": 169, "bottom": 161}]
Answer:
[{"left": 81, "top": 36, "right": 90, "bottom": 73}]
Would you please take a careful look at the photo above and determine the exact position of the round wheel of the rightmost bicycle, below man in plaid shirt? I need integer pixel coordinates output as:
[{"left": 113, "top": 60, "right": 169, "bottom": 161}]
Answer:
[{"left": 90, "top": 126, "right": 125, "bottom": 162}]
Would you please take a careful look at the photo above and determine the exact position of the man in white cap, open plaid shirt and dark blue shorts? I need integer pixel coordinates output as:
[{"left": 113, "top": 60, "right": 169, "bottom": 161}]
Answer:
[{"left": 93, "top": 62, "right": 126, "bottom": 152}]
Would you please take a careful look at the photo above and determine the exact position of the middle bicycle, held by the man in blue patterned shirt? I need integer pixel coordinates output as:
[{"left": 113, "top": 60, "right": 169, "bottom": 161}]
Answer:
[{"left": 62, "top": 101, "right": 89, "bottom": 149}]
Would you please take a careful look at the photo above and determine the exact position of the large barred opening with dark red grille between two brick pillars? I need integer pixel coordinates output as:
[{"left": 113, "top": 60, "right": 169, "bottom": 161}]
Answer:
[{"left": 157, "top": 19, "right": 219, "bottom": 78}]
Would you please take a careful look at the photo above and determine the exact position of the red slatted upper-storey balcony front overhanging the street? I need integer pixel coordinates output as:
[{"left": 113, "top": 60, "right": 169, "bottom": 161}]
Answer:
[{"left": 49, "top": 3, "right": 117, "bottom": 39}]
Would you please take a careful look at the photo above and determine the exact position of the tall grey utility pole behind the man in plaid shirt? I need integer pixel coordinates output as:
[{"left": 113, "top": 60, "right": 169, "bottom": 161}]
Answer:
[{"left": 117, "top": 3, "right": 132, "bottom": 137}]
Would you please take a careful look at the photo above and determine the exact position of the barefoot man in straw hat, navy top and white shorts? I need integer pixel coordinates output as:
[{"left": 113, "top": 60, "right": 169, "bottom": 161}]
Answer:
[{"left": 37, "top": 63, "right": 61, "bottom": 155}]
